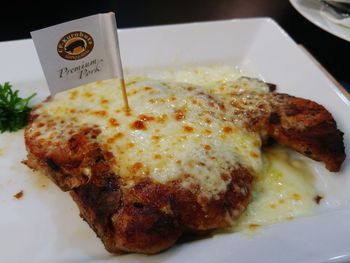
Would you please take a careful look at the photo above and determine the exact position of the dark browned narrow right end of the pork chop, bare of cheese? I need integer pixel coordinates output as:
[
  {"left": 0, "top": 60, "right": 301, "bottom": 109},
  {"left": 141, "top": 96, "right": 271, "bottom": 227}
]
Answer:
[{"left": 267, "top": 94, "right": 345, "bottom": 172}]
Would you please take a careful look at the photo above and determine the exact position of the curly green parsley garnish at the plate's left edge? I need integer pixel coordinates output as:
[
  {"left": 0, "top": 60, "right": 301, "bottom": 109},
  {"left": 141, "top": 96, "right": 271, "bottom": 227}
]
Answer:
[{"left": 0, "top": 82, "right": 36, "bottom": 133}]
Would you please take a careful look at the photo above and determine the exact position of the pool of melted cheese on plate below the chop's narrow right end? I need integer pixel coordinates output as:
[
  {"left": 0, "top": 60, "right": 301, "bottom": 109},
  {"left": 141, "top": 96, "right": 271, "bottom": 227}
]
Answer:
[{"left": 235, "top": 146, "right": 319, "bottom": 230}]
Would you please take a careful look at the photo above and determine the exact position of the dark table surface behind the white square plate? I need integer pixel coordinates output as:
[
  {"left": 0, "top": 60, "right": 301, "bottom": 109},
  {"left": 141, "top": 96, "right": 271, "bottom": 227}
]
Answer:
[{"left": 0, "top": 0, "right": 350, "bottom": 89}]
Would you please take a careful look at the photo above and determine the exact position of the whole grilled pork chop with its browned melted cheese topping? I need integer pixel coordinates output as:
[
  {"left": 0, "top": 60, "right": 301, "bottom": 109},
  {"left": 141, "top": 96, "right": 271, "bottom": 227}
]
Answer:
[{"left": 25, "top": 78, "right": 345, "bottom": 253}]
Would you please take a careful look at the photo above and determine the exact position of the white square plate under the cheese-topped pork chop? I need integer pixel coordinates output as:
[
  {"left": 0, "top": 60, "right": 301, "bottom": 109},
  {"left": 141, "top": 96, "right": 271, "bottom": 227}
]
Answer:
[{"left": 0, "top": 18, "right": 350, "bottom": 262}]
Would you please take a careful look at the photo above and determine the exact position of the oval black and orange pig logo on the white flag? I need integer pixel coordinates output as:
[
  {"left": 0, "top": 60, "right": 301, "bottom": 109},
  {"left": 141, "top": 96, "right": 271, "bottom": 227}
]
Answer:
[{"left": 57, "top": 31, "right": 94, "bottom": 60}]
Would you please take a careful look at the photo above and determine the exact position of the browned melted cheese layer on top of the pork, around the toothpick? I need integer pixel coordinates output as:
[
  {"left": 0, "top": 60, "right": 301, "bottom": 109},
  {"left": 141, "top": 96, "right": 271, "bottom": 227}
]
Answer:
[{"left": 33, "top": 76, "right": 262, "bottom": 198}]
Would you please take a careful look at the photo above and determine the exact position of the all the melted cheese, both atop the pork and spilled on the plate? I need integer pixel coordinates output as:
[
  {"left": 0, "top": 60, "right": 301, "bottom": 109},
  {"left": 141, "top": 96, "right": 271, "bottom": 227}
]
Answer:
[{"left": 29, "top": 66, "right": 317, "bottom": 226}]
